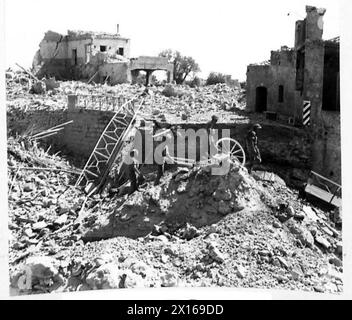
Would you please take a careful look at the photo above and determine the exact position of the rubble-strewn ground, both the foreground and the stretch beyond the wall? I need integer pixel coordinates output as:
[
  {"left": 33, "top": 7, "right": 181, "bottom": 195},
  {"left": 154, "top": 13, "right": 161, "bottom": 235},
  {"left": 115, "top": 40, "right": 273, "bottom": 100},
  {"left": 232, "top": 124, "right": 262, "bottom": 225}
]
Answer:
[{"left": 7, "top": 73, "right": 343, "bottom": 294}]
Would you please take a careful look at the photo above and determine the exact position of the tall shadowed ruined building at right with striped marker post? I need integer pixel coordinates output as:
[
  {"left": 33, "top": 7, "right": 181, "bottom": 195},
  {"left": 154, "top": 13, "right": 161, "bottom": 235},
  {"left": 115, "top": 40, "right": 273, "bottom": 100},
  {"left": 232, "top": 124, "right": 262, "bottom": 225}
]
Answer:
[{"left": 247, "top": 6, "right": 341, "bottom": 183}]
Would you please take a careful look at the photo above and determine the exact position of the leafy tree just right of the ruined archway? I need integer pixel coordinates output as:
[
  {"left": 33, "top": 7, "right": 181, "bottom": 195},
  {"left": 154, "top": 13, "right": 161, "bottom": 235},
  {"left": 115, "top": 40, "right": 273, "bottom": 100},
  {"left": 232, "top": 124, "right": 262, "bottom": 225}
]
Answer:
[{"left": 159, "top": 49, "right": 200, "bottom": 84}]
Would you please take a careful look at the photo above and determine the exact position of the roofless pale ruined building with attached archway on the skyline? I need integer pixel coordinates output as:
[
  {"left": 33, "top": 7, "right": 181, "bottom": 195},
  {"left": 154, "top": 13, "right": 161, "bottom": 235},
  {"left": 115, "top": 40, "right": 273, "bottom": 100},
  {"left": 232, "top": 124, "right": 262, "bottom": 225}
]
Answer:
[{"left": 33, "top": 25, "right": 173, "bottom": 85}]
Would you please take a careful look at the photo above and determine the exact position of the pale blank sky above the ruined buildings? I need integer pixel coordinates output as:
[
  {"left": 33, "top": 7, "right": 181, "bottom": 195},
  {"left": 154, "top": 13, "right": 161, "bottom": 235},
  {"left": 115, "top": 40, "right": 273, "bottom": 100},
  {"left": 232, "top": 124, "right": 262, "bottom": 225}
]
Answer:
[{"left": 4, "top": 0, "right": 340, "bottom": 81}]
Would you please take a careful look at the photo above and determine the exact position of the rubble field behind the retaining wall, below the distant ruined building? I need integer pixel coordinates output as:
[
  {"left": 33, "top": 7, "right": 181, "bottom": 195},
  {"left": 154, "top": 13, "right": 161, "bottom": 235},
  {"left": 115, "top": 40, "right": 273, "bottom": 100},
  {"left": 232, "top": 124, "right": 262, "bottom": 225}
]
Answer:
[{"left": 6, "top": 71, "right": 245, "bottom": 123}]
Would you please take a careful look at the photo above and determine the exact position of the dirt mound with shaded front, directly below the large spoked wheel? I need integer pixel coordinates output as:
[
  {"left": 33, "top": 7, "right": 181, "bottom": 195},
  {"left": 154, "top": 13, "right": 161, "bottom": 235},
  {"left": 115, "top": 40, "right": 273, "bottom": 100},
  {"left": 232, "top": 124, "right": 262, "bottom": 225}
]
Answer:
[{"left": 82, "top": 166, "right": 262, "bottom": 241}]
